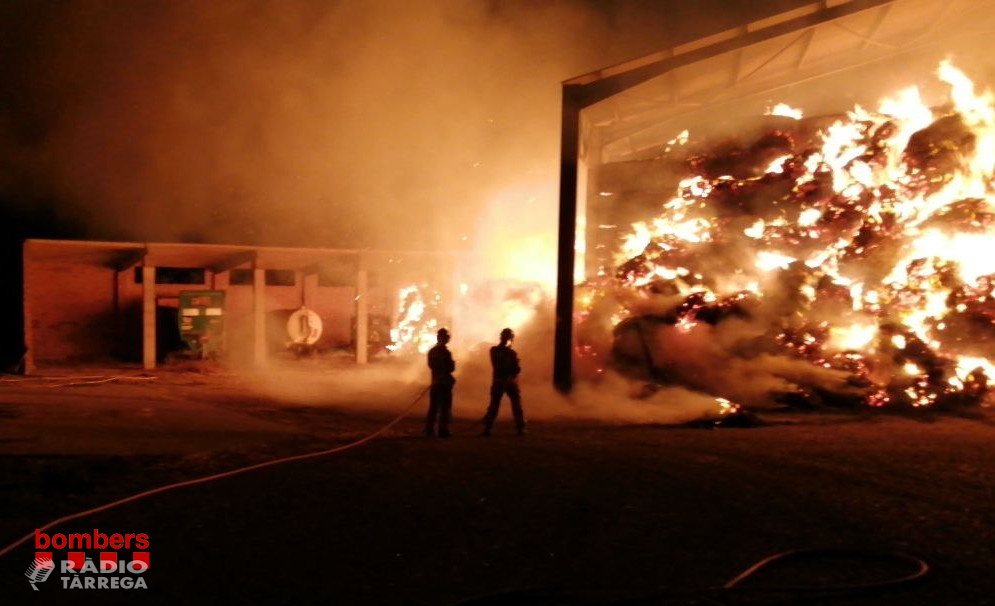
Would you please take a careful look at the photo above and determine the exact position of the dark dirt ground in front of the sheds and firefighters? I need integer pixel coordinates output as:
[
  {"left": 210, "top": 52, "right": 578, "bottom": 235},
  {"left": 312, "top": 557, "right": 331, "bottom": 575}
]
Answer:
[{"left": 0, "top": 369, "right": 995, "bottom": 605}]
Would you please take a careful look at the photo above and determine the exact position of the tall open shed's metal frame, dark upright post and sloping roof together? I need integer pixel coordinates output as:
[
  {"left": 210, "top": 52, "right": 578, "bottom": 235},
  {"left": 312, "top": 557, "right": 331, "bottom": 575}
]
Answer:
[{"left": 553, "top": 0, "right": 995, "bottom": 391}]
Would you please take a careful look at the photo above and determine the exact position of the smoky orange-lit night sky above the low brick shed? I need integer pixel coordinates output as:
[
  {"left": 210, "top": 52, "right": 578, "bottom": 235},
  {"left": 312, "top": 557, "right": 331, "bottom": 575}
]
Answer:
[{"left": 0, "top": 0, "right": 799, "bottom": 248}]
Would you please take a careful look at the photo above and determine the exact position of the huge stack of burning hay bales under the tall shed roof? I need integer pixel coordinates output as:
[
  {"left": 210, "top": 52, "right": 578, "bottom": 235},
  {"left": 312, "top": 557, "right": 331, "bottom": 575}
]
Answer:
[{"left": 576, "top": 62, "right": 995, "bottom": 408}]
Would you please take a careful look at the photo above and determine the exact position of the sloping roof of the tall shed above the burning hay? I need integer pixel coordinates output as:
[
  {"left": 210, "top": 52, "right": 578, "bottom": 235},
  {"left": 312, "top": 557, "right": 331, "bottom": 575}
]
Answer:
[{"left": 580, "top": 0, "right": 995, "bottom": 164}]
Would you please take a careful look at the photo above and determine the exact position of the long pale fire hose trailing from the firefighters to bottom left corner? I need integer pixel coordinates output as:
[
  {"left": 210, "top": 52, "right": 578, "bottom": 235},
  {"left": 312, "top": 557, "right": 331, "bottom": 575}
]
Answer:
[{"left": 0, "top": 387, "right": 429, "bottom": 558}]
